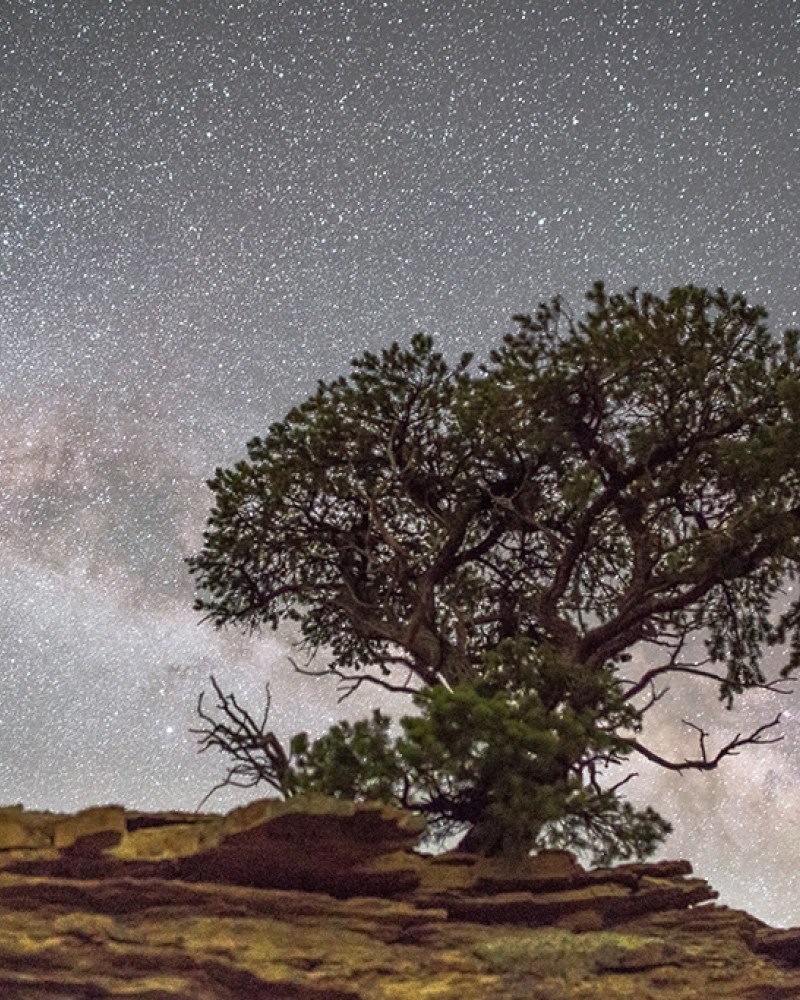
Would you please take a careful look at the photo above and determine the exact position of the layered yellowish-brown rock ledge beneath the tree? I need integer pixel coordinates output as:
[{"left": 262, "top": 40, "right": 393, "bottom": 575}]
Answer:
[{"left": 0, "top": 797, "right": 800, "bottom": 1000}]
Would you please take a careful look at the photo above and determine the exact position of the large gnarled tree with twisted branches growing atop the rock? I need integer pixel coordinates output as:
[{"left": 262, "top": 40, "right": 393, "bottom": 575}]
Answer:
[{"left": 190, "top": 283, "right": 800, "bottom": 858}]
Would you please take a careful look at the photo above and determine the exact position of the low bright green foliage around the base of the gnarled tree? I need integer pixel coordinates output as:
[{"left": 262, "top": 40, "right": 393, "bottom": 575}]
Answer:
[{"left": 282, "top": 644, "right": 670, "bottom": 864}]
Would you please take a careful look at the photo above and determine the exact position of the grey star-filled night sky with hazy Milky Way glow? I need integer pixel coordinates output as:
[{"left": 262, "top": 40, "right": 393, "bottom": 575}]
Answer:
[{"left": 0, "top": 0, "right": 800, "bottom": 924}]
